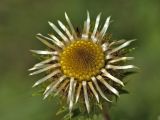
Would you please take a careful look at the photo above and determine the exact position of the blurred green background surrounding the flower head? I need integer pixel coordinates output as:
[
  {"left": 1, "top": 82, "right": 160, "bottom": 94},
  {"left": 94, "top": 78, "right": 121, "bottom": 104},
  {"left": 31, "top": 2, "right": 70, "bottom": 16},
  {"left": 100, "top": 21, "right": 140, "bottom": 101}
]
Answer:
[{"left": 0, "top": 0, "right": 160, "bottom": 120}]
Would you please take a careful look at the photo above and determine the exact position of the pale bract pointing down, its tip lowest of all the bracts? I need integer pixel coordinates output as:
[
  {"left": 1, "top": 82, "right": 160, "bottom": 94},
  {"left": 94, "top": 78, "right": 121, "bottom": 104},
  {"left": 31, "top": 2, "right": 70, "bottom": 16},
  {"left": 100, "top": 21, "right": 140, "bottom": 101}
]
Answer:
[{"left": 82, "top": 81, "right": 90, "bottom": 113}]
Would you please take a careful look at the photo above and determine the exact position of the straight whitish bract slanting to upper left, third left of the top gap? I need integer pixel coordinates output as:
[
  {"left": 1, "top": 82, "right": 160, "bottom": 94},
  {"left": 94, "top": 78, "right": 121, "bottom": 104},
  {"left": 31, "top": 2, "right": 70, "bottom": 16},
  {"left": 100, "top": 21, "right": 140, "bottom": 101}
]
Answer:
[{"left": 48, "top": 22, "right": 69, "bottom": 43}]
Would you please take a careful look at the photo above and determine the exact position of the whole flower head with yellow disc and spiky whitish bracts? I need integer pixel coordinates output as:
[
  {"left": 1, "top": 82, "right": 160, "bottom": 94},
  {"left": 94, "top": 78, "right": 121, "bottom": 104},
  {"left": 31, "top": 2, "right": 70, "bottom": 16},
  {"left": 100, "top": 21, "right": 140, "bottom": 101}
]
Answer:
[{"left": 29, "top": 11, "right": 136, "bottom": 113}]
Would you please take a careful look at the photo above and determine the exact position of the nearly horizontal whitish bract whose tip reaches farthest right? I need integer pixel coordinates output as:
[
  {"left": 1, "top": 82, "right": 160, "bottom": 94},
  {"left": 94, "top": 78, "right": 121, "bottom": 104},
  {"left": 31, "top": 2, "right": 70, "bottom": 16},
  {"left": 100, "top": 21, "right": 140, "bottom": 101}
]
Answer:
[{"left": 106, "top": 65, "right": 137, "bottom": 70}]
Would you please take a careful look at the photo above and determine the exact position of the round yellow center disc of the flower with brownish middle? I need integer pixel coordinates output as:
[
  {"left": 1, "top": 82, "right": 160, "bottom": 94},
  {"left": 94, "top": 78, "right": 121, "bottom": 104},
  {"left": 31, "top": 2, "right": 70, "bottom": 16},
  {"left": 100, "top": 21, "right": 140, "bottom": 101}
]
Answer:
[{"left": 60, "top": 40, "right": 105, "bottom": 81}]
